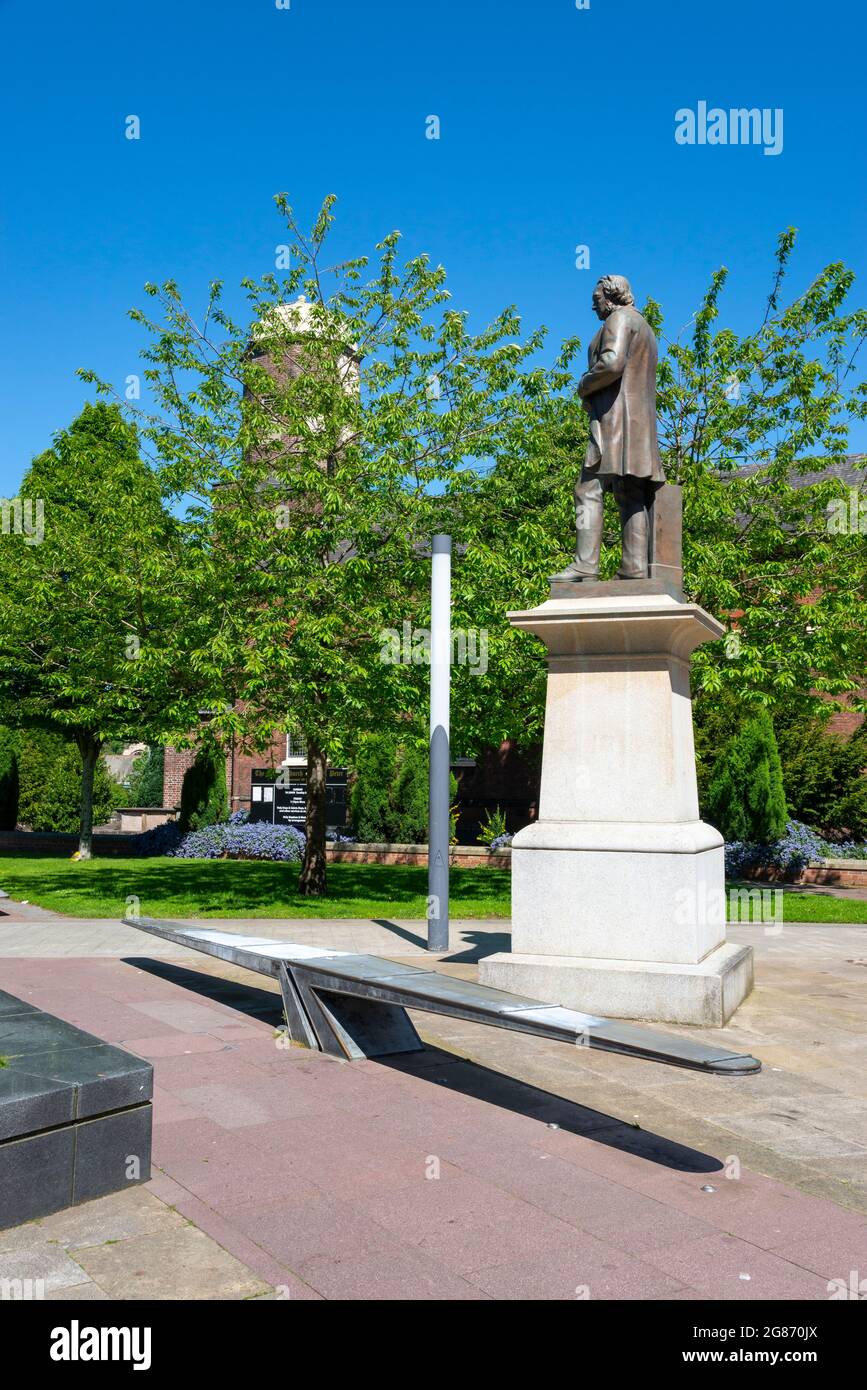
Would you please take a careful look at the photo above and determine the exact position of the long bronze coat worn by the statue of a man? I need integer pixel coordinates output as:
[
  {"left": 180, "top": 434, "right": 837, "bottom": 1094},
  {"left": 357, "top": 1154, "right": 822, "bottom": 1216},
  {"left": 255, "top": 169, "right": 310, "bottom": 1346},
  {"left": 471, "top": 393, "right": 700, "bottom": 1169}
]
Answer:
[{"left": 578, "top": 306, "right": 666, "bottom": 482}]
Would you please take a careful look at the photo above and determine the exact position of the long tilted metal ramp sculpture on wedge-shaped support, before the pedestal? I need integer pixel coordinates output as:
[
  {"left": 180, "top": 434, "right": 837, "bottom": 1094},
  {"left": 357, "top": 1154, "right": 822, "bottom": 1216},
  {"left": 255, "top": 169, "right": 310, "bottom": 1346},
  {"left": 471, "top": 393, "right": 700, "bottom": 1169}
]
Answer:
[{"left": 124, "top": 917, "right": 761, "bottom": 1076}]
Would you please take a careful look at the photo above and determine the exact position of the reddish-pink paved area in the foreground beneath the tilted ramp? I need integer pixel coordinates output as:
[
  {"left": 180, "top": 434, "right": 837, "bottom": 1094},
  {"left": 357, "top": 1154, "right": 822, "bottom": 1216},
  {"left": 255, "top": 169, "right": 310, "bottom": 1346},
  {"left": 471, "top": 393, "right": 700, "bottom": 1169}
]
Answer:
[{"left": 3, "top": 958, "right": 867, "bottom": 1300}]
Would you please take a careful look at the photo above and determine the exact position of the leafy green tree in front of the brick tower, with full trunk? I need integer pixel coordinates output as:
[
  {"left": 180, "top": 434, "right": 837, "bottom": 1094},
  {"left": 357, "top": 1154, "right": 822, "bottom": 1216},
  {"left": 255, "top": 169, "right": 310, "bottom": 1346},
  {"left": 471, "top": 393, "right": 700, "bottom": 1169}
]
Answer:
[{"left": 83, "top": 196, "right": 555, "bottom": 894}]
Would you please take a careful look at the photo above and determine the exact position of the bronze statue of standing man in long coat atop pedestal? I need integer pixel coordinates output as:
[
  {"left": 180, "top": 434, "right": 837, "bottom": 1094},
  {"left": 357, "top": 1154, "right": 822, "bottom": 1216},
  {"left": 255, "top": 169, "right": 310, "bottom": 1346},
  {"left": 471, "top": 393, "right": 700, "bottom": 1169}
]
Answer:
[{"left": 553, "top": 275, "right": 666, "bottom": 582}]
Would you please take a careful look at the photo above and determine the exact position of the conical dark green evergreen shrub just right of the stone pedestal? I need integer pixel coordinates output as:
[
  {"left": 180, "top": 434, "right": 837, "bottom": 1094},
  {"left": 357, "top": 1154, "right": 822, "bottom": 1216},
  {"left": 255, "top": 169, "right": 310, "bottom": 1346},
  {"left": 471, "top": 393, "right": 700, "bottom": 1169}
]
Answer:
[{"left": 707, "top": 710, "right": 786, "bottom": 844}]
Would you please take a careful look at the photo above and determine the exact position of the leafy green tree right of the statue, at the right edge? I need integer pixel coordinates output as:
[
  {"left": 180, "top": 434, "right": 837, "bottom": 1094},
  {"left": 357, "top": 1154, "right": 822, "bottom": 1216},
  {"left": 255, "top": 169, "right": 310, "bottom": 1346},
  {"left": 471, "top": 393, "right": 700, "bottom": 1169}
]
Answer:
[{"left": 647, "top": 229, "right": 867, "bottom": 709}]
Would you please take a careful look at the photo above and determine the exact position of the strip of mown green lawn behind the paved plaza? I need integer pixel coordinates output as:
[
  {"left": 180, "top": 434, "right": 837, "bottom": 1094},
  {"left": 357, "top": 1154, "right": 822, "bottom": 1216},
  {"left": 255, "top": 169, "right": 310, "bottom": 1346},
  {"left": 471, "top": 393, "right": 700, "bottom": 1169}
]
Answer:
[{"left": 0, "top": 855, "right": 867, "bottom": 923}]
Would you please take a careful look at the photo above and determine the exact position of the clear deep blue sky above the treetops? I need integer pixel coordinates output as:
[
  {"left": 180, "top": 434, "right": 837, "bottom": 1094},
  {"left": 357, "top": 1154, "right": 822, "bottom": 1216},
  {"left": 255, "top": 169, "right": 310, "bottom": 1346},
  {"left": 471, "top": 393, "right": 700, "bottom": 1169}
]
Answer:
[{"left": 0, "top": 0, "right": 867, "bottom": 496}]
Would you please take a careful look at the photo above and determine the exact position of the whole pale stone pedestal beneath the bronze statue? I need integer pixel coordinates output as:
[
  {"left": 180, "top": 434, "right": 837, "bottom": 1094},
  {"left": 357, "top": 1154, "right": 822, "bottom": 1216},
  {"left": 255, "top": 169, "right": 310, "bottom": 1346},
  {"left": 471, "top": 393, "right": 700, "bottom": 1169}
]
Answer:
[{"left": 481, "top": 592, "right": 753, "bottom": 1026}]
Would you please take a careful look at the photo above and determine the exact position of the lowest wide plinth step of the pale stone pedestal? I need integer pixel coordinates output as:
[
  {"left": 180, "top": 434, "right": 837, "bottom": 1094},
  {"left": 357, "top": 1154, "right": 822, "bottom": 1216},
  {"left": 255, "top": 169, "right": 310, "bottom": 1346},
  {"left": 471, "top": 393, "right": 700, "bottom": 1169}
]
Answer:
[{"left": 479, "top": 942, "right": 753, "bottom": 1029}]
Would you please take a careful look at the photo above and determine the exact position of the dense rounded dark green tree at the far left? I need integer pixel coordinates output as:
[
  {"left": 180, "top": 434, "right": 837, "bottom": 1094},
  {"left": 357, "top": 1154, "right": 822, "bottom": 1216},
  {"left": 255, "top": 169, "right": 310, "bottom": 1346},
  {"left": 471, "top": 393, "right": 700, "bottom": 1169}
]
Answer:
[{"left": 0, "top": 403, "right": 200, "bottom": 859}]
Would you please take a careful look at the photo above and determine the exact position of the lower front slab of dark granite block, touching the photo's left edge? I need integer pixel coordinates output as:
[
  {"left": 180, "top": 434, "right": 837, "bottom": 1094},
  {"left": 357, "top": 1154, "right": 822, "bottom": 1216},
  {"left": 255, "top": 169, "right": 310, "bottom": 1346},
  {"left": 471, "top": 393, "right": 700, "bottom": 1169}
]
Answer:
[{"left": 0, "top": 1125, "right": 75, "bottom": 1230}]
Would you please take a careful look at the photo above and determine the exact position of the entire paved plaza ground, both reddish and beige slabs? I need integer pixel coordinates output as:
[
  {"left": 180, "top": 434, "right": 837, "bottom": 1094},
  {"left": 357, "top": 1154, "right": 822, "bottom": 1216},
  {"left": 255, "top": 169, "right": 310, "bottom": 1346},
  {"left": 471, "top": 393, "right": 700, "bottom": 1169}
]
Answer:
[{"left": 0, "top": 899, "right": 867, "bottom": 1301}]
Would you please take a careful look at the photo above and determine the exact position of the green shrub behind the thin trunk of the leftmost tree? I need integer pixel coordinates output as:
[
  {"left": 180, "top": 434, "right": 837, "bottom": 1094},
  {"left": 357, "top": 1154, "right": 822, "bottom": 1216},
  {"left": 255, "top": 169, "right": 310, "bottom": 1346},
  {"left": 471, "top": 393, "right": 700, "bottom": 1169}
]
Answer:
[{"left": 18, "top": 728, "right": 117, "bottom": 833}]
